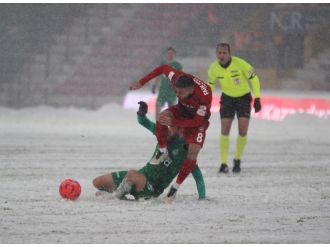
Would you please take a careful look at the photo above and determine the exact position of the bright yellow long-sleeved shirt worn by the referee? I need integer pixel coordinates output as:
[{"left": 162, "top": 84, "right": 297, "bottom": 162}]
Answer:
[{"left": 208, "top": 56, "right": 260, "bottom": 98}]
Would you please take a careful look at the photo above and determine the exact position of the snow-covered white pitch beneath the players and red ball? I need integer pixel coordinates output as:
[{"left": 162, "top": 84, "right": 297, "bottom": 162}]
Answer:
[{"left": 0, "top": 99, "right": 330, "bottom": 244}]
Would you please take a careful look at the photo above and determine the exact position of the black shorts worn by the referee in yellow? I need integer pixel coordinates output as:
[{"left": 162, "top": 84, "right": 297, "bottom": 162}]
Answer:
[{"left": 220, "top": 93, "right": 252, "bottom": 119}]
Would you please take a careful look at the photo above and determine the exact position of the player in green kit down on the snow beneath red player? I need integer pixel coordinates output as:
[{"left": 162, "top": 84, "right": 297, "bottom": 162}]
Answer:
[{"left": 93, "top": 102, "right": 205, "bottom": 199}]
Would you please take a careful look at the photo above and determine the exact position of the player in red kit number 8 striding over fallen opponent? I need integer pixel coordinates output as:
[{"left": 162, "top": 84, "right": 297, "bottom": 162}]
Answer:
[{"left": 129, "top": 65, "right": 212, "bottom": 200}]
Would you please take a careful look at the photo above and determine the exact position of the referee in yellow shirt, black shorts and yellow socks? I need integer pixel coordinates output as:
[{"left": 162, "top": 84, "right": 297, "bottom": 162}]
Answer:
[{"left": 208, "top": 43, "right": 261, "bottom": 173}]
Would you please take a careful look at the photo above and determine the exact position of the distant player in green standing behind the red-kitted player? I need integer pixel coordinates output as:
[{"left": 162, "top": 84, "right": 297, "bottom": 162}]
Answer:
[{"left": 152, "top": 47, "right": 183, "bottom": 119}]
